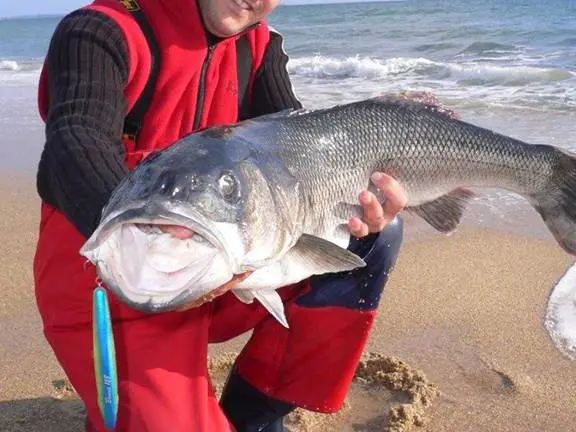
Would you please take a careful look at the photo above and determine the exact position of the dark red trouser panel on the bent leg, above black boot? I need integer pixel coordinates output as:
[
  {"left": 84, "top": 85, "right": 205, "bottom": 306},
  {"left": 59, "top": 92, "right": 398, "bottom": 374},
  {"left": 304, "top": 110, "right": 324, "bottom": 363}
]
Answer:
[{"left": 237, "top": 296, "right": 375, "bottom": 413}]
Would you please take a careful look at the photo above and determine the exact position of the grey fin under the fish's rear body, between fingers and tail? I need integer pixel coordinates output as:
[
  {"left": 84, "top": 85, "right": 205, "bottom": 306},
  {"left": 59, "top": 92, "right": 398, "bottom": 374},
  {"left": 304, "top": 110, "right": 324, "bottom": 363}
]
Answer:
[{"left": 406, "top": 188, "right": 478, "bottom": 234}]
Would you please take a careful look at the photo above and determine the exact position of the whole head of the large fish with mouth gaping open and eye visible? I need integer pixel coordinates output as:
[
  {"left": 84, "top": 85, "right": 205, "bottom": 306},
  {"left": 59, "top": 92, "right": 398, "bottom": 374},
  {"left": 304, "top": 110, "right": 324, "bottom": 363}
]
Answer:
[{"left": 80, "top": 130, "right": 296, "bottom": 312}]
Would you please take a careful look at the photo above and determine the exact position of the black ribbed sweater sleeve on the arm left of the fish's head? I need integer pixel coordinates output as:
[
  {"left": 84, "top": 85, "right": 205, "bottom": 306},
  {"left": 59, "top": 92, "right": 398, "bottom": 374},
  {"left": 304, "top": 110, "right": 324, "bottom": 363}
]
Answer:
[{"left": 37, "top": 10, "right": 128, "bottom": 237}]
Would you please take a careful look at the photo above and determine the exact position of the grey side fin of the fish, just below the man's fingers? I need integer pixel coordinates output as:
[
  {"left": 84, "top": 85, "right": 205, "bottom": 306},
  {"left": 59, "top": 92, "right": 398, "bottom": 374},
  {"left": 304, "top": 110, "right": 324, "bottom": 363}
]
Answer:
[{"left": 284, "top": 234, "right": 366, "bottom": 274}]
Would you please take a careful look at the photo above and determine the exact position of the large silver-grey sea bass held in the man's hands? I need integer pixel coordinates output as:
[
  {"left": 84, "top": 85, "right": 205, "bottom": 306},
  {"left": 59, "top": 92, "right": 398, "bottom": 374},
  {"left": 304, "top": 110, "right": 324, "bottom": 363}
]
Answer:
[{"left": 81, "top": 93, "right": 576, "bottom": 326}]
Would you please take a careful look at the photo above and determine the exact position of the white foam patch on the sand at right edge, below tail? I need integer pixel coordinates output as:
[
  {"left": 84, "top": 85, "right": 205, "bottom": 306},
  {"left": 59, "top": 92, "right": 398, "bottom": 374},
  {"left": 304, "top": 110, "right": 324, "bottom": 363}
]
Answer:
[{"left": 544, "top": 264, "right": 576, "bottom": 361}]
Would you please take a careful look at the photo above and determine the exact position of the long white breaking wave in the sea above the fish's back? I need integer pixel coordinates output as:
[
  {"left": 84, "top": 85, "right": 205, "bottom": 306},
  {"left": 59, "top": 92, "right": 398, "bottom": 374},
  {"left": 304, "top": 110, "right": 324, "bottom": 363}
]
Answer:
[{"left": 288, "top": 54, "right": 576, "bottom": 110}]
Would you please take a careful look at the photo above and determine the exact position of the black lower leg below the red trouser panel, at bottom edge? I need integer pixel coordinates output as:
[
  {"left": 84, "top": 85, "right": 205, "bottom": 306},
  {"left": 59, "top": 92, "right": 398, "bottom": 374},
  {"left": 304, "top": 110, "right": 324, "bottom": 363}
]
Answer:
[{"left": 220, "top": 368, "right": 296, "bottom": 432}]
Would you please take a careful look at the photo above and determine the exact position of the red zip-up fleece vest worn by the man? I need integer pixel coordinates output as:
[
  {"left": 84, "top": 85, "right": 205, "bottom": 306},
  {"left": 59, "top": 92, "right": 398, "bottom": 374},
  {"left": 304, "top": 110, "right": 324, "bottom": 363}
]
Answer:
[{"left": 38, "top": 0, "right": 269, "bottom": 164}]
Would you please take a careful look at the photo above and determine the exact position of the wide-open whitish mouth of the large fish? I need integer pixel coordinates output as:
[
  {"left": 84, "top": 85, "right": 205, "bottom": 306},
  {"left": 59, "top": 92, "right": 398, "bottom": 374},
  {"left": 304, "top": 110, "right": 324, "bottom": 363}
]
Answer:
[{"left": 80, "top": 203, "right": 234, "bottom": 313}]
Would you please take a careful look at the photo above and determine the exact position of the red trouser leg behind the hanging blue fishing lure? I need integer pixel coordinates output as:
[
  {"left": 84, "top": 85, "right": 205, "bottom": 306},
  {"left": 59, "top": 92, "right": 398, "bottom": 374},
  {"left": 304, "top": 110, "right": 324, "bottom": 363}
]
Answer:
[{"left": 35, "top": 205, "right": 229, "bottom": 432}]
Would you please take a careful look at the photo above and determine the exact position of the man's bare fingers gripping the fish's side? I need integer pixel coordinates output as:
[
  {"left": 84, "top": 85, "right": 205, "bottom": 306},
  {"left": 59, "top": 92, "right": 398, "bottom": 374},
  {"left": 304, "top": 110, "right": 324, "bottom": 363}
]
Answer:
[{"left": 348, "top": 172, "right": 408, "bottom": 237}]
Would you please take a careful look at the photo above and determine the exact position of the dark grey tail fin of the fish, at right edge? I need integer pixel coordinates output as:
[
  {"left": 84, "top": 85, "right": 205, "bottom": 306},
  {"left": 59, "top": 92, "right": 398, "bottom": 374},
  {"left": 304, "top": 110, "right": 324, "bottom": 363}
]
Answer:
[{"left": 530, "top": 148, "right": 576, "bottom": 255}]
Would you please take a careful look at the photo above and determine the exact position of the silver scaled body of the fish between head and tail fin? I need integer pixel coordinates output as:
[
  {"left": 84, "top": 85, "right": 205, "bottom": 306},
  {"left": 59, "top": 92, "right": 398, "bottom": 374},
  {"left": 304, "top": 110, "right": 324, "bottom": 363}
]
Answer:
[{"left": 254, "top": 98, "right": 555, "bottom": 216}]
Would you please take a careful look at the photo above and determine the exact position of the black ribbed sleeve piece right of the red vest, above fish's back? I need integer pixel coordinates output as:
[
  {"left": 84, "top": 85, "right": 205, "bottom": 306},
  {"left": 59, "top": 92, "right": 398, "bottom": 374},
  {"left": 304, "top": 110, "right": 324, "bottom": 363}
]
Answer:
[{"left": 251, "top": 31, "right": 302, "bottom": 117}]
